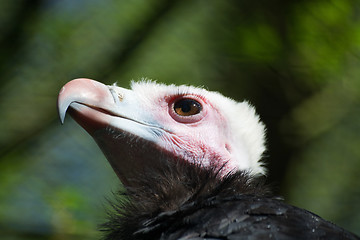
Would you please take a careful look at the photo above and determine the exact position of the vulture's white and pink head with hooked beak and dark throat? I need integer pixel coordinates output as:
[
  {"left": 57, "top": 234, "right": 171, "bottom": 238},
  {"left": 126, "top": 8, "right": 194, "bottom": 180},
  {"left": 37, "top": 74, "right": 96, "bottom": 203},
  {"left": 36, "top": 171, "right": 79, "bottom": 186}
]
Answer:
[{"left": 58, "top": 78, "right": 265, "bottom": 186}]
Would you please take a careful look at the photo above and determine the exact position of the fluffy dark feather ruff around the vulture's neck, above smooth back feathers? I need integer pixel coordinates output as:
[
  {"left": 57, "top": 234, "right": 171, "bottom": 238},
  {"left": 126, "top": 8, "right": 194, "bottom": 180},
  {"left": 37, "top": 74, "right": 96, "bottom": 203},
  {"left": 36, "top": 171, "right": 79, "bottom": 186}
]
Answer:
[{"left": 101, "top": 158, "right": 271, "bottom": 239}]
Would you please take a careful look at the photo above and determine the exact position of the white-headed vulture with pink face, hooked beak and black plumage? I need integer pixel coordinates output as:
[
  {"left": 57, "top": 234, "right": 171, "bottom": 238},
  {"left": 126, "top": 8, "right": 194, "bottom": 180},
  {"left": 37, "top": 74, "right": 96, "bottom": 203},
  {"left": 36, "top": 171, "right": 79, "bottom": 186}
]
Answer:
[{"left": 58, "top": 78, "right": 360, "bottom": 240}]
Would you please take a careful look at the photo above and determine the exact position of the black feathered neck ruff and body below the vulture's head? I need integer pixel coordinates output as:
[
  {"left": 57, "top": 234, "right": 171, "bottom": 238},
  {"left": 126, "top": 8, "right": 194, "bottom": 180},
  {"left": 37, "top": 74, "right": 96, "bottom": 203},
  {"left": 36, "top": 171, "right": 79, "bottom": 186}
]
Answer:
[{"left": 102, "top": 161, "right": 360, "bottom": 240}]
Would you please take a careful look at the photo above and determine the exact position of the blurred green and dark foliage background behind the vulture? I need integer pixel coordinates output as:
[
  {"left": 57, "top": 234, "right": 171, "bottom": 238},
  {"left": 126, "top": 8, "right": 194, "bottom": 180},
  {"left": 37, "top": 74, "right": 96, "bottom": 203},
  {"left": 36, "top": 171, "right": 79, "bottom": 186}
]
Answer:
[{"left": 0, "top": 0, "right": 360, "bottom": 240}]
